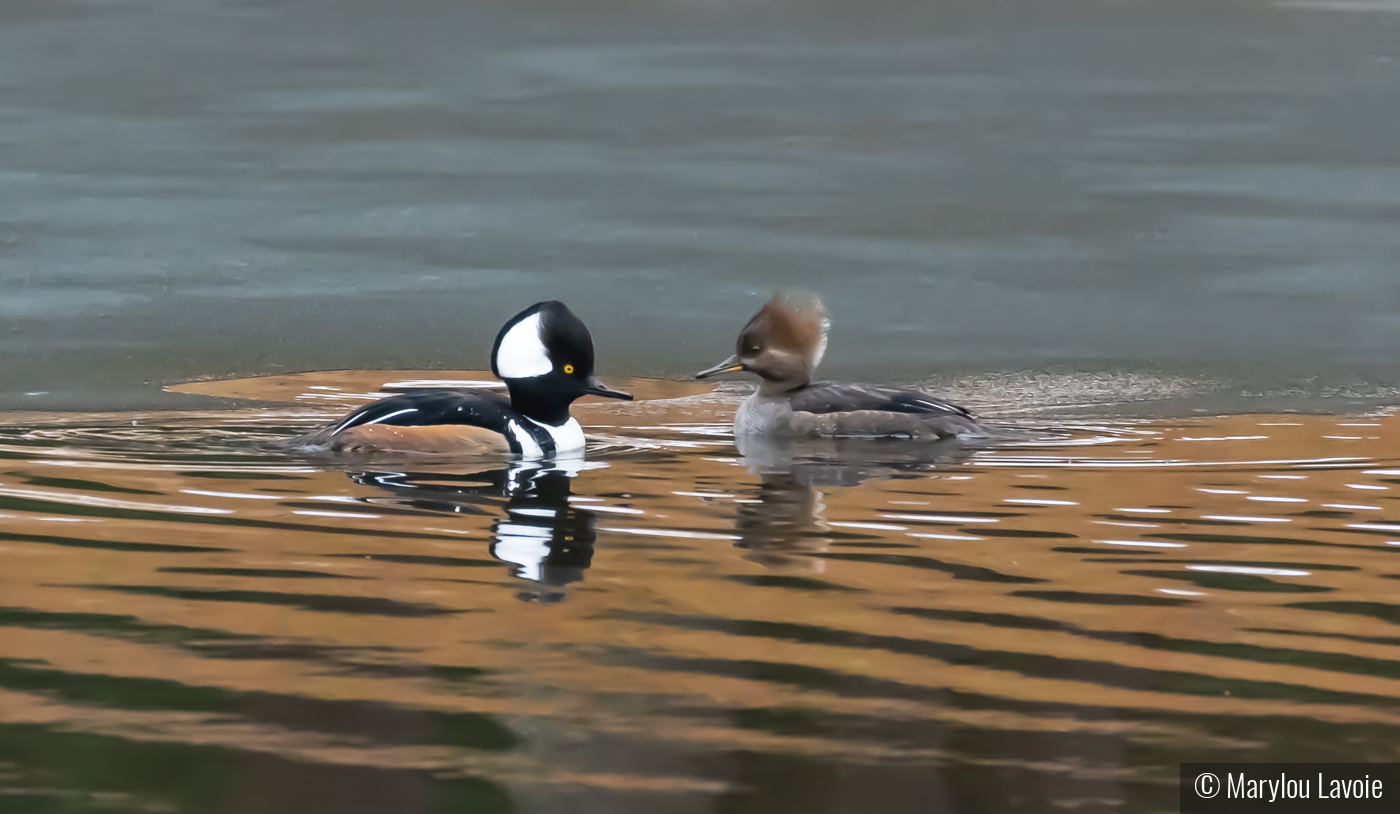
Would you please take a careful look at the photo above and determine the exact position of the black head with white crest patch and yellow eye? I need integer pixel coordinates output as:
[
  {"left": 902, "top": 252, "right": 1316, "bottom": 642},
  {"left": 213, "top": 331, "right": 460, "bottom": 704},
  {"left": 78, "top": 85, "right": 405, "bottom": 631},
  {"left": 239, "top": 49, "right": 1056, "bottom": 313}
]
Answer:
[{"left": 491, "top": 300, "right": 631, "bottom": 426}]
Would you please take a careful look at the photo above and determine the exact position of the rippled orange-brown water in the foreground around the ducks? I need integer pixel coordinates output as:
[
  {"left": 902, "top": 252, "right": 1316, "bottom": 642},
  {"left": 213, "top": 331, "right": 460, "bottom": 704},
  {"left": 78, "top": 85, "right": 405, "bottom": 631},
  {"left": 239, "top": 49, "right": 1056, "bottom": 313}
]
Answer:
[{"left": 0, "top": 371, "right": 1400, "bottom": 813}]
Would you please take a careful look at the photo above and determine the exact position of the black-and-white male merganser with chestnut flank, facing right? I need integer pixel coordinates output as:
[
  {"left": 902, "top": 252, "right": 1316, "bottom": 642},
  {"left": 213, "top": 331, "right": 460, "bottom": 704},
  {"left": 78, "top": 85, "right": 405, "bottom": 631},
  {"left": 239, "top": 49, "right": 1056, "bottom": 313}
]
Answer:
[{"left": 298, "top": 300, "right": 631, "bottom": 458}]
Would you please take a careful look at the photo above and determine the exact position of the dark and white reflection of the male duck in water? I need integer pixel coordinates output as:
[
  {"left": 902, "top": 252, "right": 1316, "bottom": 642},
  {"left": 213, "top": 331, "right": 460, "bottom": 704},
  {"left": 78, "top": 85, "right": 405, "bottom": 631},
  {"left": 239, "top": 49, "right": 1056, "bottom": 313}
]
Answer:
[{"left": 353, "top": 460, "right": 596, "bottom": 596}]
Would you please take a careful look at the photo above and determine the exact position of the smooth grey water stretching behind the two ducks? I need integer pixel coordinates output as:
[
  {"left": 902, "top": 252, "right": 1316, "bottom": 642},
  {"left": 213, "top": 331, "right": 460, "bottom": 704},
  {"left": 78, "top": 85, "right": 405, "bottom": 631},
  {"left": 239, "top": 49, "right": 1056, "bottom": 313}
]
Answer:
[{"left": 0, "top": 0, "right": 1400, "bottom": 409}]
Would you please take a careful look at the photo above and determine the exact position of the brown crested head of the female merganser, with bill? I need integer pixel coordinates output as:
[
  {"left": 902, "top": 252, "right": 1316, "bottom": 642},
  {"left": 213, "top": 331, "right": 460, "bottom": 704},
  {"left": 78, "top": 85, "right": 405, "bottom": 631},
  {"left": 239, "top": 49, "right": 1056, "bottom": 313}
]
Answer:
[{"left": 696, "top": 291, "right": 832, "bottom": 395}]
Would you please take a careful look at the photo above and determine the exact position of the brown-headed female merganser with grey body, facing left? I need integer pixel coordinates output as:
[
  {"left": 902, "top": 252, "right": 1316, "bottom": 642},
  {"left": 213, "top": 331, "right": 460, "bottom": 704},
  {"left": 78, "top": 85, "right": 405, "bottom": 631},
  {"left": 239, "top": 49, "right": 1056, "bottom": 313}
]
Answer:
[{"left": 696, "top": 291, "right": 987, "bottom": 440}]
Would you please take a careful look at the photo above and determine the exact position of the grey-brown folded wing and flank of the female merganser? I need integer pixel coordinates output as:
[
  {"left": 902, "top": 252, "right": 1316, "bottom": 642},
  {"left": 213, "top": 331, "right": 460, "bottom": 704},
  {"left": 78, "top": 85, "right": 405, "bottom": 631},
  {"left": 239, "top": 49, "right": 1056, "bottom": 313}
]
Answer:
[{"left": 788, "top": 382, "right": 984, "bottom": 439}]
